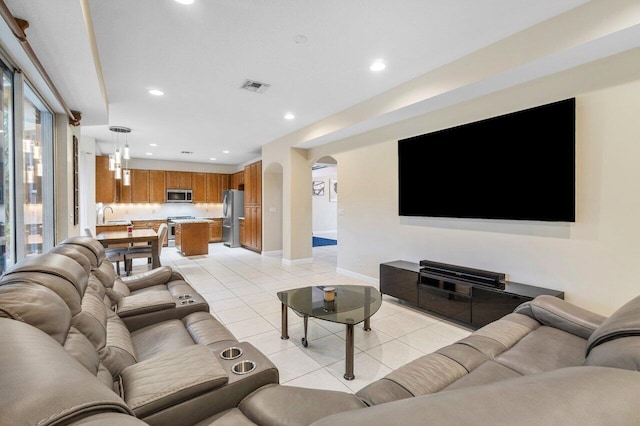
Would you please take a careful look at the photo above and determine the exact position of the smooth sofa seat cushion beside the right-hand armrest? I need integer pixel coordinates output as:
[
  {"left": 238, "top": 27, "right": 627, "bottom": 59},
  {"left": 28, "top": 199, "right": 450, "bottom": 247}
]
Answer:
[{"left": 495, "top": 326, "right": 586, "bottom": 374}]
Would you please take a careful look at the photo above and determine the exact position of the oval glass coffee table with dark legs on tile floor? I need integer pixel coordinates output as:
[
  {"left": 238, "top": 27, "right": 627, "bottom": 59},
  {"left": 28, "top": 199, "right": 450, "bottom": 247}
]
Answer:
[{"left": 278, "top": 285, "right": 382, "bottom": 380}]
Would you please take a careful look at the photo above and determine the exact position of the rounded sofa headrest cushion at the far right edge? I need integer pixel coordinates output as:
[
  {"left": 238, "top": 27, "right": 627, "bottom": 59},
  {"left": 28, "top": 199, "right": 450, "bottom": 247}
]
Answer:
[{"left": 587, "top": 296, "right": 640, "bottom": 356}]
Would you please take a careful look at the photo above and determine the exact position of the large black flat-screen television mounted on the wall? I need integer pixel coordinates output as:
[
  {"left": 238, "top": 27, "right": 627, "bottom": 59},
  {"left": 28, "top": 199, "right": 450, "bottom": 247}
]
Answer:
[{"left": 398, "top": 98, "right": 575, "bottom": 222}]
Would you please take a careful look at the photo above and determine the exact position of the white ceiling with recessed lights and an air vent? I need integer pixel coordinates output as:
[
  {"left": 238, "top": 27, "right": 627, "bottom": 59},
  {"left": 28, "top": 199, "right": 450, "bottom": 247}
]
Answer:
[{"left": 5, "top": 0, "right": 620, "bottom": 165}]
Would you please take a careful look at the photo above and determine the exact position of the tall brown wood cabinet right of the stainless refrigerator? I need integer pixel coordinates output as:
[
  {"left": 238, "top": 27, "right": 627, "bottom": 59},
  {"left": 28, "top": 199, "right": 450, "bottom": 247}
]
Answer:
[{"left": 240, "top": 161, "right": 262, "bottom": 253}]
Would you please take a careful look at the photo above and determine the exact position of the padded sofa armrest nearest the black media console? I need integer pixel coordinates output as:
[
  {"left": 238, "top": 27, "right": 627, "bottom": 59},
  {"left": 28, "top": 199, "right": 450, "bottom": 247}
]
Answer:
[{"left": 514, "top": 295, "right": 606, "bottom": 339}]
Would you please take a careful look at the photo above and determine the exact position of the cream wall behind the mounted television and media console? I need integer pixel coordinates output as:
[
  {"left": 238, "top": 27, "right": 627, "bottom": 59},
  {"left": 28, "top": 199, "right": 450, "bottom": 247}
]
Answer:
[{"left": 333, "top": 81, "right": 640, "bottom": 315}]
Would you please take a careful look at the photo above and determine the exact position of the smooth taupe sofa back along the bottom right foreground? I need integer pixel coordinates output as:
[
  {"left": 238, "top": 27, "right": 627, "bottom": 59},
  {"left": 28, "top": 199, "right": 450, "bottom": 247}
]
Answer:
[{"left": 312, "top": 367, "right": 640, "bottom": 426}]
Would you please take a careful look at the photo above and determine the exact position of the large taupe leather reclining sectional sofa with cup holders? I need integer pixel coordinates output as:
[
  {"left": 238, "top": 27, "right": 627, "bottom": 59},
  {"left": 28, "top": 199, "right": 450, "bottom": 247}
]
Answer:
[{"left": 0, "top": 237, "right": 640, "bottom": 426}]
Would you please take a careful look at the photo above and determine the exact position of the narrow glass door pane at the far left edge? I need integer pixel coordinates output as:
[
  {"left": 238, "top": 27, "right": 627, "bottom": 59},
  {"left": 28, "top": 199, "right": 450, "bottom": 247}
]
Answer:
[{"left": 0, "top": 67, "right": 15, "bottom": 273}]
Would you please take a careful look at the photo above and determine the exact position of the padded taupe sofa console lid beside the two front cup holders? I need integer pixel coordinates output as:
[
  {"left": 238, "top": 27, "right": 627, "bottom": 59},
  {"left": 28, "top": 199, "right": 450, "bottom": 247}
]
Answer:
[{"left": 120, "top": 345, "right": 229, "bottom": 417}]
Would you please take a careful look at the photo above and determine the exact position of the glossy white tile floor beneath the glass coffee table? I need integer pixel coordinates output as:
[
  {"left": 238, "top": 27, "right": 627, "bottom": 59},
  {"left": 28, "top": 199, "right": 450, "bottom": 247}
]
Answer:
[{"left": 127, "top": 244, "right": 471, "bottom": 392}]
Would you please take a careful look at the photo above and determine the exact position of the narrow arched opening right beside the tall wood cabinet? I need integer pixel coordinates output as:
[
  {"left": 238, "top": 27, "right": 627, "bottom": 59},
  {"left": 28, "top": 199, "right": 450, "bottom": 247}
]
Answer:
[{"left": 262, "top": 163, "right": 284, "bottom": 256}]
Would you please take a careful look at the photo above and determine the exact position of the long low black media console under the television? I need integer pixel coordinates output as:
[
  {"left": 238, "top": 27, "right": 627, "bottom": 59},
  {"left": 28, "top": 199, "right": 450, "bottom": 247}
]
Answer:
[{"left": 380, "top": 260, "right": 564, "bottom": 328}]
